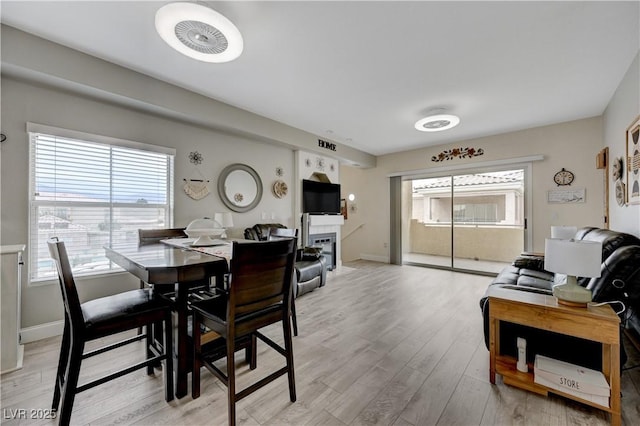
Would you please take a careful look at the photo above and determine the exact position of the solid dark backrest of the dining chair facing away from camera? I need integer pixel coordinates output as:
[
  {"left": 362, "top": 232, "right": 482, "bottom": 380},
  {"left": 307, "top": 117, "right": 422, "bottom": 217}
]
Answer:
[{"left": 229, "top": 238, "right": 296, "bottom": 317}]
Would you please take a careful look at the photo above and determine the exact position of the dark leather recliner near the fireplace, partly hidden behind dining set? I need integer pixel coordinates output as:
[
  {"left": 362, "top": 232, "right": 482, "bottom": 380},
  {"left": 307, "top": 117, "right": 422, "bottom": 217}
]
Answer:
[{"left": 244, "top": 223, "right": 327, "bottom": 297}]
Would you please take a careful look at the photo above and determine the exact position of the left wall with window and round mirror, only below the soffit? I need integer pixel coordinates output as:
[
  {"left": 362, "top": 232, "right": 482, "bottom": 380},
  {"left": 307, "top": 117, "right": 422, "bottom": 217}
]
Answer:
[{"left": 1, "top": 78, "right": 295, "bottom": 328}]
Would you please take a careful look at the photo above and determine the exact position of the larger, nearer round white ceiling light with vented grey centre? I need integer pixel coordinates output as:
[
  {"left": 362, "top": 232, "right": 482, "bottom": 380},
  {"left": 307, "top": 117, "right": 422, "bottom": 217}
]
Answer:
[{"left": 156, "top": 3, "right": 243, "bottom": 63}]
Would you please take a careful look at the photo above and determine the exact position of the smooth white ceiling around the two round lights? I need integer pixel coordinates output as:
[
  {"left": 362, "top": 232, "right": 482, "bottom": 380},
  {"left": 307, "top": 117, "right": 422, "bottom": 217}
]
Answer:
[{"left": 0, "top": 0, "right": 640, "bottom": 155}]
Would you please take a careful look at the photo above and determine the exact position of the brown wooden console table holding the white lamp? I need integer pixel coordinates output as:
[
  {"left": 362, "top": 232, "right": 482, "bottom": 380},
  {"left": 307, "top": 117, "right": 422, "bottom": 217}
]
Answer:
[{"left": 489, "top": 288, "right": 621, "bottom": 426}]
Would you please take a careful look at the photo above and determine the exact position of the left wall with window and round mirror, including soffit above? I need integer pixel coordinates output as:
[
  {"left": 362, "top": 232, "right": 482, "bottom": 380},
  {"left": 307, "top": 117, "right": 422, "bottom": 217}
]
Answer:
[{"left": 0, "top": 25, "right": 375, "bottom": 341}]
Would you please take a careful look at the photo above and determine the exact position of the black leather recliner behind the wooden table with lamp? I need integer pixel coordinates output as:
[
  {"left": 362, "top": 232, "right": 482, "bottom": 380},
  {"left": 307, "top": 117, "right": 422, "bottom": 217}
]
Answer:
[{"left": 480, "top": 227, "right": 640, "bottom": 369}]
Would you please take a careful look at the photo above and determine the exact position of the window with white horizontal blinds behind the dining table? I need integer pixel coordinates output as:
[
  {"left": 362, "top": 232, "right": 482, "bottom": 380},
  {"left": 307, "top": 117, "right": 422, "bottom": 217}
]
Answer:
[{"left": 28, "top": 123, "right": 175, "bottom": 281}]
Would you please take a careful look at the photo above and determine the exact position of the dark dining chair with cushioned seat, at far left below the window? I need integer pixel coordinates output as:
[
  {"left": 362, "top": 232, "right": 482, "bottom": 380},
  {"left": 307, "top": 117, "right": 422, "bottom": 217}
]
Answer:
[{"left": 47, "top": 237, "right": 174, "bottom": 425}]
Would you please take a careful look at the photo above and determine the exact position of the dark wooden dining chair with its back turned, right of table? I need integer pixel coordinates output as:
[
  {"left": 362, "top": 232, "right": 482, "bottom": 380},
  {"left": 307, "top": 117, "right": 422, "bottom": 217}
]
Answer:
[{"left": 191, "top": 238, "right": 296, "bottom": 425}]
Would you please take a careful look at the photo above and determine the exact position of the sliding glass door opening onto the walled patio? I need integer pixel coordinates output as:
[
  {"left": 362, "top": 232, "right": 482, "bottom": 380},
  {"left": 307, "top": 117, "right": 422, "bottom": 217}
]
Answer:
[{"left": 402, "top": 168, "right": 525, "bottom": 273}]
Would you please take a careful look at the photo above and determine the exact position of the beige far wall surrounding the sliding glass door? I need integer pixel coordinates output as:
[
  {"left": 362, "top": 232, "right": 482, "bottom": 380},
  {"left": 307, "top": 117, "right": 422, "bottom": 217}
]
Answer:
[{"left": 340, "top": 116, "right": 604, "bottom": 262}]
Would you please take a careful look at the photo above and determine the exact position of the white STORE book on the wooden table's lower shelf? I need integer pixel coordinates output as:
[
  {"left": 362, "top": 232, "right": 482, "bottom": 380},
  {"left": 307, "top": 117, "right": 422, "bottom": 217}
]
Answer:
[{"left": 533, "top": 355, "right": 611, "bottom": 407}]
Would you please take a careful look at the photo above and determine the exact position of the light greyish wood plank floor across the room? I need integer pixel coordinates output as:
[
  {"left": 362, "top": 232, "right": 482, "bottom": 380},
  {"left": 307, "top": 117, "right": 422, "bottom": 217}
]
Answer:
[{"left": 1, "top": 261, "right": 640, "bottom": 426}]
